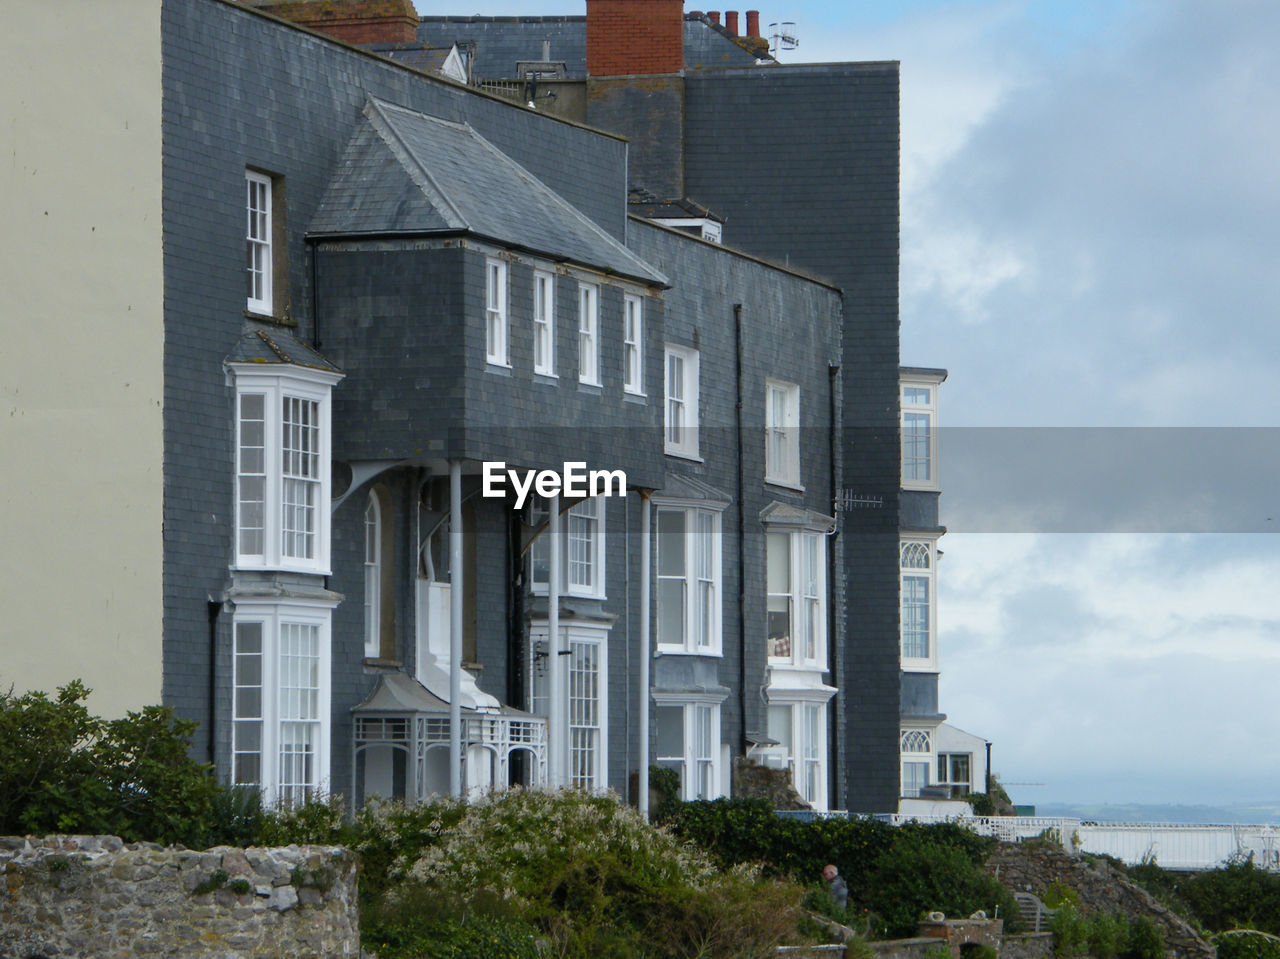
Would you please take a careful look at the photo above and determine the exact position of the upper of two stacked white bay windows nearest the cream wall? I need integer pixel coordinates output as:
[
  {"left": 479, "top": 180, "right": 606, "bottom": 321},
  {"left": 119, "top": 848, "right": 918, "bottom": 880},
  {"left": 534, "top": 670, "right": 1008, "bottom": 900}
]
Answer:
[{"left": 229, "top": 364, "right": 342, "bottom": 574}]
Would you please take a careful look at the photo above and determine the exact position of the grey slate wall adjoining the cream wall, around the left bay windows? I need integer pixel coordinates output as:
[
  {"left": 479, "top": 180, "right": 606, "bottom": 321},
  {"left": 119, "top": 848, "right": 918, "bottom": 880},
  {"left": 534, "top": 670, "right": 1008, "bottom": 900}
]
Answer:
[{"left": 161, "top": 0, "right": 640, "bottom": 763}]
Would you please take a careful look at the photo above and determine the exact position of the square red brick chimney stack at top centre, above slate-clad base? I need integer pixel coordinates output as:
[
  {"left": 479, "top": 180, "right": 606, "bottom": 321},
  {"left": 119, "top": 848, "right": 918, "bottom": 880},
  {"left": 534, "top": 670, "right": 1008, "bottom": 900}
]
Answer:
[{"left": 586, "top": 0, "right": 685, "bottom": 77}]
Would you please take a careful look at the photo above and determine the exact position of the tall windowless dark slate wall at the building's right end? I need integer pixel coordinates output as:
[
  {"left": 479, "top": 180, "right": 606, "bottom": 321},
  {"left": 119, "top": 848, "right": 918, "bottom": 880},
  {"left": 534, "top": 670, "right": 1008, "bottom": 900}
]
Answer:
[{"left": 685, "top": 63, "right": 900, "bottom": 812}]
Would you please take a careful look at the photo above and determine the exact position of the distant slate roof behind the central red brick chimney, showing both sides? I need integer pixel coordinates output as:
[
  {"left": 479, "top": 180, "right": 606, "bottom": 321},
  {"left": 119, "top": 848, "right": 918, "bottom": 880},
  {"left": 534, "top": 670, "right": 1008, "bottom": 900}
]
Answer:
[{"left": 417, "top": 13, "right": 755, "bottom": 79}]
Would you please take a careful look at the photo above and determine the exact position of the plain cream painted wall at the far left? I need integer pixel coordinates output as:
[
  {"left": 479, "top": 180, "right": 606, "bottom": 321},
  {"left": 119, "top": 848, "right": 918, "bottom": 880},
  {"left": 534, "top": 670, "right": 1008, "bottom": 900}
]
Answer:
[{"left": 0, "top": 0, "right": 164, "bottom": 716}]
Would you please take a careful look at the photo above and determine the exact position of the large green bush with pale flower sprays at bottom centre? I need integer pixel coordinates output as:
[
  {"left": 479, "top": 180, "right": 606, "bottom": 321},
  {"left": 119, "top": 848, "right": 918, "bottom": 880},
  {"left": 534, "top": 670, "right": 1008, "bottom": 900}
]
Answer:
[{"left": 371, "top": 790, "right": 801, "bottom": 959}]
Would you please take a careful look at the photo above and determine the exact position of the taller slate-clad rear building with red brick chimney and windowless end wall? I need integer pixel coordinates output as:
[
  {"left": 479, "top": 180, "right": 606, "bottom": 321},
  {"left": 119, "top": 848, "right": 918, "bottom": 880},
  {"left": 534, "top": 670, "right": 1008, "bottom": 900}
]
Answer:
[{"left": 393, "top": 0, "right": 916, "bottom": 812}]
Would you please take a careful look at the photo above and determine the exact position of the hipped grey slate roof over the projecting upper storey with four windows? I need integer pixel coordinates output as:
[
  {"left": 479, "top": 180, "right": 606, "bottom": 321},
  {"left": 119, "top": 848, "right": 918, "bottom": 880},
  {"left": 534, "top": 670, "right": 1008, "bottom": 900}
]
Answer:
[{"left": 307, "top": 97, "right": 667, "bottom": 286}]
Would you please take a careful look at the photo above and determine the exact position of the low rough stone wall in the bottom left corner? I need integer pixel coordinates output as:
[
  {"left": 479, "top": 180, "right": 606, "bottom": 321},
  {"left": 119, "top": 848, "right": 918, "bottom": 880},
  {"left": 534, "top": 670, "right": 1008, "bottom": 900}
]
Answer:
[{"left": 0, "top": 836, "right": 360, "bottom": 959}]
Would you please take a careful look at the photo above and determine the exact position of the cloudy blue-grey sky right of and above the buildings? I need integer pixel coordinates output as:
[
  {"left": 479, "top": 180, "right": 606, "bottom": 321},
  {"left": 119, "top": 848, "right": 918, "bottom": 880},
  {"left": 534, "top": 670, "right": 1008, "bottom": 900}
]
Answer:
[{"left": 442, "top": 0, "right": 1280, "bottom": 804}]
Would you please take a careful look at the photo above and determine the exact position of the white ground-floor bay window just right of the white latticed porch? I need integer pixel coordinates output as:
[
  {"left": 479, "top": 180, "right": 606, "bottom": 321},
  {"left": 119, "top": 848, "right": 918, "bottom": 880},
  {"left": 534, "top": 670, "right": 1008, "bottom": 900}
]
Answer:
[{"left": 527, "top": 620, "right": 609, "bottom": 793}]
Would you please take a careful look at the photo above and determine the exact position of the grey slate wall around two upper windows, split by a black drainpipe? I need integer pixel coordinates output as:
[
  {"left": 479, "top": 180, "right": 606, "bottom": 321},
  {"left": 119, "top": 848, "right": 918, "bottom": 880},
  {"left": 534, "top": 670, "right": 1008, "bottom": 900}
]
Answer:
[{"left": 630, "top": 220, "right": 842, "bottom": 803}]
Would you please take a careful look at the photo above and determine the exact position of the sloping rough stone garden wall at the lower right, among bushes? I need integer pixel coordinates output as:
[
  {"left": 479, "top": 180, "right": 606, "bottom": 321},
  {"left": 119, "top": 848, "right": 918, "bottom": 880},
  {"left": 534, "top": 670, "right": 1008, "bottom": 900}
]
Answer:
[{"left": 987, "top": 842, "right": 1217, "bottom": 959}]
